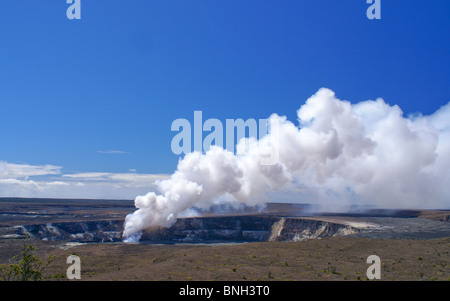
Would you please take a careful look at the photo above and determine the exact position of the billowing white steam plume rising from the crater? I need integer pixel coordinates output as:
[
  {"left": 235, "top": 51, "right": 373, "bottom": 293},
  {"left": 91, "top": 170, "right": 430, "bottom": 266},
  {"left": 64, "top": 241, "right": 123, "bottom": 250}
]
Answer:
[{"left": 124, "top": 88, "right": 450, "bottom": 241}]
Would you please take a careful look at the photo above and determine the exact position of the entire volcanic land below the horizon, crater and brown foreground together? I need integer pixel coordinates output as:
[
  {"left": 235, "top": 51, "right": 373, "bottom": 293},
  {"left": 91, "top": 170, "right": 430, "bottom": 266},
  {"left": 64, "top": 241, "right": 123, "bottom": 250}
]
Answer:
[{"left": 0, "top": 199, "right": 450, "bottom": 280}]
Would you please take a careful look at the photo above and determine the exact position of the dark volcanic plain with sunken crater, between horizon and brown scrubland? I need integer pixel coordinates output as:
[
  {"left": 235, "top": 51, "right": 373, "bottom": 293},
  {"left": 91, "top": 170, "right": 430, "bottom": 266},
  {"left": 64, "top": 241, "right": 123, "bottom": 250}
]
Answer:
[{"left": 0, "top": 199, "right": 450, "bottom": 244}]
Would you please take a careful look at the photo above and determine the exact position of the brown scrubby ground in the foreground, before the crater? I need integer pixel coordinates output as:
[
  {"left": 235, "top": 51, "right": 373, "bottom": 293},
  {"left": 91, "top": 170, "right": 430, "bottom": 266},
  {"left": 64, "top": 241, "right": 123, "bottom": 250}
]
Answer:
[{"left": 0, "top": 238, "right": 442, "bottom": 281}]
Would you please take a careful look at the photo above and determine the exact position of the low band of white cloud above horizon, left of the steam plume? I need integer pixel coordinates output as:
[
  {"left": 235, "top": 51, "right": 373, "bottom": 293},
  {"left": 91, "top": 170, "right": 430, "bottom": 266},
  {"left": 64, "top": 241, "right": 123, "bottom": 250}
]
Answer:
[{"left": 0, "top": 161, "right": 168, "bottom": 199}]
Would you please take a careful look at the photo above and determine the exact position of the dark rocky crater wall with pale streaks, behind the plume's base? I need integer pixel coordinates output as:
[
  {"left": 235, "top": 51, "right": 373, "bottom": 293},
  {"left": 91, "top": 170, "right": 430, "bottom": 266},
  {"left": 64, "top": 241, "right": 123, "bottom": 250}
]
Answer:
[{"left": 7, "top": 216, "right": 358, "bottom": 243}]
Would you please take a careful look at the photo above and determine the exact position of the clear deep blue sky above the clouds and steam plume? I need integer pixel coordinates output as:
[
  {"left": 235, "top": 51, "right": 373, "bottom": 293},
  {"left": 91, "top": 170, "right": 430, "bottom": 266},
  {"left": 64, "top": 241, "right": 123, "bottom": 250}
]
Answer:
[{"left": 0, "top": 0, "right": 450, "bottom": 199}]
